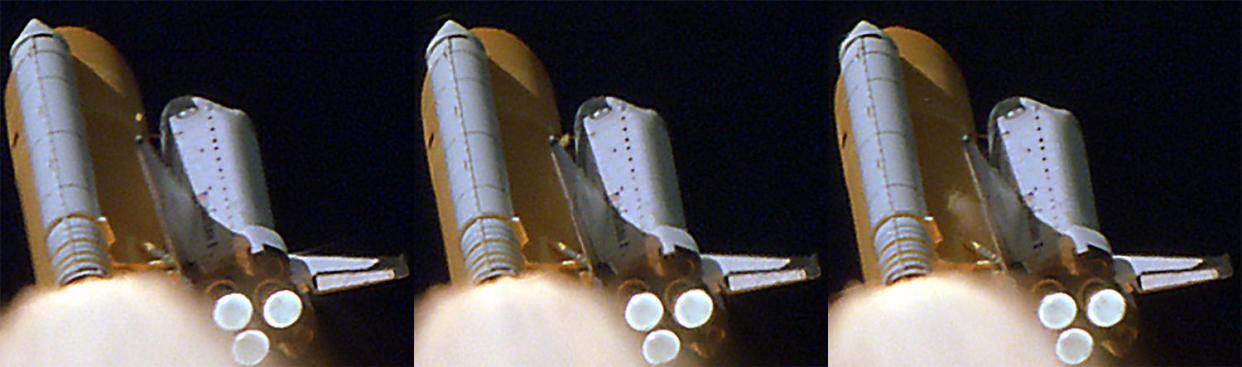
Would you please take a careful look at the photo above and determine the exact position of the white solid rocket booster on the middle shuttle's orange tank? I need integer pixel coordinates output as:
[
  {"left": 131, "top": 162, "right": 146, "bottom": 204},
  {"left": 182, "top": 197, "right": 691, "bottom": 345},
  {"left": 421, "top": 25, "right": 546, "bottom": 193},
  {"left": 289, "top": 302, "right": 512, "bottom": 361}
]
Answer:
[{"left": 425, "top": 20, "right": 523, "bottom": 284}]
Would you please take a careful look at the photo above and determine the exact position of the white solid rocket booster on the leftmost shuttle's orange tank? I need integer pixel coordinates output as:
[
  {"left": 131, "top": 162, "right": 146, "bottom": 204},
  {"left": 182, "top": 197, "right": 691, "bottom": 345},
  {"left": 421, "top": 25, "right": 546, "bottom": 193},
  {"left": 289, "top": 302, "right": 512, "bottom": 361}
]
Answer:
[{"left": 9, "top": 19, "right": 109, "bottom": 285}]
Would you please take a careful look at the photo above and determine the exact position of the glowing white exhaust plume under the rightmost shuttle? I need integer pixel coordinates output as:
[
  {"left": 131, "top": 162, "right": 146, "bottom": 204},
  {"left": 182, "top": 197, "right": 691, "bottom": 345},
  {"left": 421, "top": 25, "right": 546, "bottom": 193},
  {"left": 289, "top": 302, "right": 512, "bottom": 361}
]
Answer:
[{"left": 828, "top": 272, "right": 1064, "bottom": 367}]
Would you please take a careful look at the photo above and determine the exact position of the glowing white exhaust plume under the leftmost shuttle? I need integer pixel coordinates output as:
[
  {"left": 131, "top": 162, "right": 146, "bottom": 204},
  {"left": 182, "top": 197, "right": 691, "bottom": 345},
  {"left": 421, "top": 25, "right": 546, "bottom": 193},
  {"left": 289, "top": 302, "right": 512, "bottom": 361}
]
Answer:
[{"left": 0, "top": 274, "right": 236, "bottom": 367}]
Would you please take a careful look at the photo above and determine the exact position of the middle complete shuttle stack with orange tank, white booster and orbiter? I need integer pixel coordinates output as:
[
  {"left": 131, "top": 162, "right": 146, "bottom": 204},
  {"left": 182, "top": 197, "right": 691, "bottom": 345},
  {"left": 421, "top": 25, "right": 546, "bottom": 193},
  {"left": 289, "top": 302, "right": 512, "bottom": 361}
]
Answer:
[{"left": 421, "top": 21, "right": 820, "bottom": 365}]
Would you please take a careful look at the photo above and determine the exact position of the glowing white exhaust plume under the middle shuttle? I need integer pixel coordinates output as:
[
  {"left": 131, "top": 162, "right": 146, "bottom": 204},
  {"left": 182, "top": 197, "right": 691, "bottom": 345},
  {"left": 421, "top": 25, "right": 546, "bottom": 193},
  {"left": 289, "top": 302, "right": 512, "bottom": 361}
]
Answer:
[{"left": 414, "top": 272, "right": 646, "bottom": 367}]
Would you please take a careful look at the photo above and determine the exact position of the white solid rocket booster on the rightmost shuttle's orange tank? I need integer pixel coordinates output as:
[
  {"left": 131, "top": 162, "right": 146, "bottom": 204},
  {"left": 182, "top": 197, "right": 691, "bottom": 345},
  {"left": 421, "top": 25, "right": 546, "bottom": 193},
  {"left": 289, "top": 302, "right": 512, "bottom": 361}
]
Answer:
[{"left": 837, "top": 21, "right": 933, "bottom": 284}]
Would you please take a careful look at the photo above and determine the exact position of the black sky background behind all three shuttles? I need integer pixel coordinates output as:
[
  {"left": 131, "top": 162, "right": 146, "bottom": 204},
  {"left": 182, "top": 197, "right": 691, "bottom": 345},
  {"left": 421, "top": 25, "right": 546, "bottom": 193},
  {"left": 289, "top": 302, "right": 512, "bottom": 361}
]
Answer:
[{"left": 0, "top": 2, "right": 1242, "bottom": 366}]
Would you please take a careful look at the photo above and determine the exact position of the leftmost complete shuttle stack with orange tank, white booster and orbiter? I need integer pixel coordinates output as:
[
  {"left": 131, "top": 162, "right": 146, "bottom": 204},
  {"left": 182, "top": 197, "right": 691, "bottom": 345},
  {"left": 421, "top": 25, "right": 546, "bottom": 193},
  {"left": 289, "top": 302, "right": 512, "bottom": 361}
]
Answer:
[{"left": 5, "top": 20, "right": 409, "bottom": 366}]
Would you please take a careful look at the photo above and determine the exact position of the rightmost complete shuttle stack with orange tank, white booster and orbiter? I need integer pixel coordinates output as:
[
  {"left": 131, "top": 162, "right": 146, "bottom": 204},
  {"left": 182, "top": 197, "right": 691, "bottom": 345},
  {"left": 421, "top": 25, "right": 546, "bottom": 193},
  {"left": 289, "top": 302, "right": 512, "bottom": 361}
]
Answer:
[{"left": 833, "top": 21, "right": 1232, "bottom": 365}]
